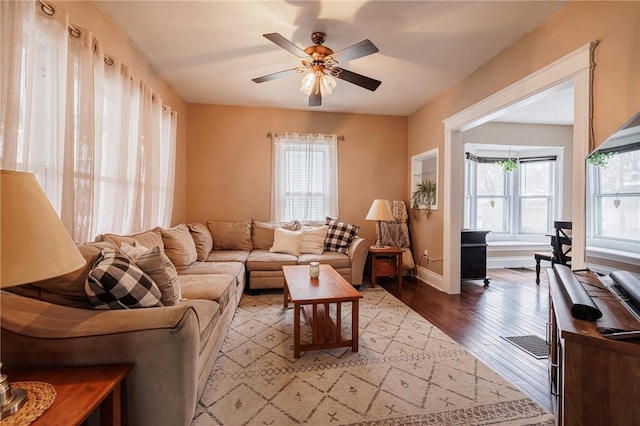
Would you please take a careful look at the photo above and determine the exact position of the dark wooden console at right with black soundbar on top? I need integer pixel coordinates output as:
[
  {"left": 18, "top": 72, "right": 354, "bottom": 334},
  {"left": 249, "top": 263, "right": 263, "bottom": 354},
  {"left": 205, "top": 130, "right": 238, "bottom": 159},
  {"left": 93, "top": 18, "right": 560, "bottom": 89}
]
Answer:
[{"left": 547, "top": 269, "right": 640, "bottom": 426}]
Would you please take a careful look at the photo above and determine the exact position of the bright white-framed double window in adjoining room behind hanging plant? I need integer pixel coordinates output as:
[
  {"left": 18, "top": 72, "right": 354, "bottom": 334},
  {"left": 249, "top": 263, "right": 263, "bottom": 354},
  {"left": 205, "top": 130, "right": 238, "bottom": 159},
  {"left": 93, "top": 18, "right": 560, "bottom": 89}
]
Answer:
[{"left": 464, "top": 153, "right": 557, "bottom": 236}]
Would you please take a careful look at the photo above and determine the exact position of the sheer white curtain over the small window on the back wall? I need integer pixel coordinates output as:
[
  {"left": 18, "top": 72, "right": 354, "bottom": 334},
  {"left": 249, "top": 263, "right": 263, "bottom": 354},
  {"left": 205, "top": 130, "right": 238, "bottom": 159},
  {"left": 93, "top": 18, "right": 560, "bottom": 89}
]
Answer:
[{"left": 271, "top": 133, "right": 338, "bottom": 221}]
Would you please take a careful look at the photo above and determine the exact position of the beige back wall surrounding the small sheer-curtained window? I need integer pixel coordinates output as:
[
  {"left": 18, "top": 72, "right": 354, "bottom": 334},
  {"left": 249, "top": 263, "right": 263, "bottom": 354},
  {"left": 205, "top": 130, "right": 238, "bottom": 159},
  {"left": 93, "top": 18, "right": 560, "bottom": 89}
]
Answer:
[{"left": 187, "top": 104, "right": 407, "bottom": 240}]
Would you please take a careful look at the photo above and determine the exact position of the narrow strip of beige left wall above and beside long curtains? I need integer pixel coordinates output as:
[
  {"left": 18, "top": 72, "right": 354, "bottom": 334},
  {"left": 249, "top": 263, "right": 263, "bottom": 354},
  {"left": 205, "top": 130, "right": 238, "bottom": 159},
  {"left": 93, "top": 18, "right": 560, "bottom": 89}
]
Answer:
[{"left": 59, "top": 1, "right": 187, "bottom": 224}]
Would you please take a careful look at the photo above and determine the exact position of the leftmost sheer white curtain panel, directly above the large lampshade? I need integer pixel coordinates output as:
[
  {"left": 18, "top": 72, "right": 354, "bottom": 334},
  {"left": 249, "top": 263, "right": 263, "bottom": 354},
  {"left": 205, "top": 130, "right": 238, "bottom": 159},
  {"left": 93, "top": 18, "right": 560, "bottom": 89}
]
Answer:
[{"left": 0, "top": 1, "right": 68, "bottom": 206}]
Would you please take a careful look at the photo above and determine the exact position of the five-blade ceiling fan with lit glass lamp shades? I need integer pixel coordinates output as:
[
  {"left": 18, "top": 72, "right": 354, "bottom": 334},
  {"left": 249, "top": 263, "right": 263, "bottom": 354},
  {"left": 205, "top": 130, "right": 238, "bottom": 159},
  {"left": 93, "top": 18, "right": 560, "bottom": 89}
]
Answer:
[{"left": 252, "top": 32, "right": 382, "bottom": 106}]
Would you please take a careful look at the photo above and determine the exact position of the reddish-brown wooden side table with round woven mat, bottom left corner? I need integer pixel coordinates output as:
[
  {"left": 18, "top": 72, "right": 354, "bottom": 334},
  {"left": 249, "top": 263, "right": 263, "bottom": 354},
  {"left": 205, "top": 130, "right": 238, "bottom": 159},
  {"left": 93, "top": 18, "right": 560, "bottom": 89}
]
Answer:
[{"left": 6, "top": 364, "right": 132, "bottom": 426}]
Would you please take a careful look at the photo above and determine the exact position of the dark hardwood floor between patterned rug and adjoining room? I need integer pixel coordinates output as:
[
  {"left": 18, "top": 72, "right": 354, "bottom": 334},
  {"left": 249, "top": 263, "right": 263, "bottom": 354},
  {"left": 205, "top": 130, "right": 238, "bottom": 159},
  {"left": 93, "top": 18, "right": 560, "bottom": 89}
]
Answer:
[{"left": 378, "top": 269, "right": 552, "bottom": 411}]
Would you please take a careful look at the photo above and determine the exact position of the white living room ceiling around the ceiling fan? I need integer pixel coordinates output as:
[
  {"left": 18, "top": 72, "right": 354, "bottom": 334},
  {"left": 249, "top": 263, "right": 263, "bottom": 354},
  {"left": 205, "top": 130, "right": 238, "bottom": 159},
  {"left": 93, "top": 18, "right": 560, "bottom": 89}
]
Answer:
[{"left": 95, "top": 0, "right": 568, "bottom": 116}]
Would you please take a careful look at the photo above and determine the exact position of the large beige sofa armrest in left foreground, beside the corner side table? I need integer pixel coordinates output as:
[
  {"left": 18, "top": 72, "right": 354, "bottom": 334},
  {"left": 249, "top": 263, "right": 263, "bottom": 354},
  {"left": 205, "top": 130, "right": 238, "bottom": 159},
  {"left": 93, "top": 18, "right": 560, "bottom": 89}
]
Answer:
[{"left": 0, "top": 291, "right": 202, "bottom": 426}]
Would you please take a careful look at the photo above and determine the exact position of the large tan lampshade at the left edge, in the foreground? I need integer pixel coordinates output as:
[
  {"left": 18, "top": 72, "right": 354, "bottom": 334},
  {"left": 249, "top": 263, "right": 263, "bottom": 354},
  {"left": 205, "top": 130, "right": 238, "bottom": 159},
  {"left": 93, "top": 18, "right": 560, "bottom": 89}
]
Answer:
[{"left": 0, "top": 170, "right": 85, "bottom": 288}]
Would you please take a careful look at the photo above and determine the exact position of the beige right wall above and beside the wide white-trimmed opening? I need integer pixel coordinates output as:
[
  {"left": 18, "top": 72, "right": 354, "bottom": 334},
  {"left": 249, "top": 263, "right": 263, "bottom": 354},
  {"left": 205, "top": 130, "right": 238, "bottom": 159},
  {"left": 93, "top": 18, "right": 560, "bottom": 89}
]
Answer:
[{"left": 407, "top": 1, "right": 640, "bottom": 274}]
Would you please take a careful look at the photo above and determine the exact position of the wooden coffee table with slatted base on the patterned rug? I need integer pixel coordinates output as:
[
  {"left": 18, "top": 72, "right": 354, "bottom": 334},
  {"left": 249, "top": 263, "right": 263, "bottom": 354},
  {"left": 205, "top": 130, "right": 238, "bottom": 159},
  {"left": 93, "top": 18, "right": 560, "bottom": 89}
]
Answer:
[{"left": 282, "top": 265, "right": 362, "bottom": 358}]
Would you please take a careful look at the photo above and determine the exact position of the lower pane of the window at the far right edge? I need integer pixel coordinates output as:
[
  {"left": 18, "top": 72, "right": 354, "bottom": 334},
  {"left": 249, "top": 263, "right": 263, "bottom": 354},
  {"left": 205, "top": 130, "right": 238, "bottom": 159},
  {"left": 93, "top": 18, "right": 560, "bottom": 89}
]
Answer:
[{"left": 597, "top": 196, "right": 640, "bottom": 241}]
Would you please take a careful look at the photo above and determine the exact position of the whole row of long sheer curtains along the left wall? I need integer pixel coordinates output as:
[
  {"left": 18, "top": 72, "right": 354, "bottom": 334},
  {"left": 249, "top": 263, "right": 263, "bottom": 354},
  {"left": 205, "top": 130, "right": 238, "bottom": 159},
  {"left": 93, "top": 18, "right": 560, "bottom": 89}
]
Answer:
[{"left": 0, "top": 1, "right": 177, "bottom": 242}]
